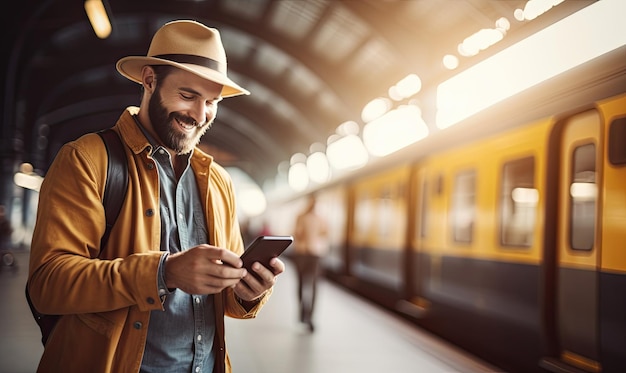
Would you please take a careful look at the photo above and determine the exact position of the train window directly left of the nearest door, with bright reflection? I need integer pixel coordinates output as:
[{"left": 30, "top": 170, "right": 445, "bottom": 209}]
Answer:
[{"left": 500, "top": 157, "right": 539, "bottom": 247}]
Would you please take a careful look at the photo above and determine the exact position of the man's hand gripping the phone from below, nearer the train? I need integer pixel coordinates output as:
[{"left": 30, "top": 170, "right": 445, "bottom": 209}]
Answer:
[{"left": 234, "top": 258, "right": 285, "bottom": 302}]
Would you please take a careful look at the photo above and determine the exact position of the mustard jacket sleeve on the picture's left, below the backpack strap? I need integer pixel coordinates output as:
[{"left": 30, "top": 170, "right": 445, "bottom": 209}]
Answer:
[{"left": 29, "top": 134, "right": 161, "bottom": 314}]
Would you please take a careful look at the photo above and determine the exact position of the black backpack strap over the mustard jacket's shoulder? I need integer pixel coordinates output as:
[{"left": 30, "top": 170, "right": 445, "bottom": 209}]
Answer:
[{"left": 98, "top": 128, "right": 128, "bottom": 250}]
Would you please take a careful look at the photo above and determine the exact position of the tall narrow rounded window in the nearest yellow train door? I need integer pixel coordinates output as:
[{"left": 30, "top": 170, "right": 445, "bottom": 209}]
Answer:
[{"left": 569, "top": 144, "right": 598, "bottom": 250}]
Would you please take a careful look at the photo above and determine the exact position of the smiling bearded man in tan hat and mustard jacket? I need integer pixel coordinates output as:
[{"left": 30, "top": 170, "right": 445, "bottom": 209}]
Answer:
[{"left": 29, "top": 21, "right": 284, "bottom": 373}]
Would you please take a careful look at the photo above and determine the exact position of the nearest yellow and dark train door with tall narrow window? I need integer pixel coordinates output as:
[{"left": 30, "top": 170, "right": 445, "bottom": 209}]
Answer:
[{"left": 555, "top": 110, "right": 603, "bottom": 372}]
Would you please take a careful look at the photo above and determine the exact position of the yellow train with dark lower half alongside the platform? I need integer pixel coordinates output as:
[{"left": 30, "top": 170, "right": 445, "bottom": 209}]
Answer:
[{"left": 266, "top": 47, "right": 626, "bottom": 372}]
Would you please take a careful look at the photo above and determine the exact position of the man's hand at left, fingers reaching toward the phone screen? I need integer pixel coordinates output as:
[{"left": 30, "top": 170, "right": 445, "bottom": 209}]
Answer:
[{"left": 165, "top": 245, "right": 248, "bottom": 294}]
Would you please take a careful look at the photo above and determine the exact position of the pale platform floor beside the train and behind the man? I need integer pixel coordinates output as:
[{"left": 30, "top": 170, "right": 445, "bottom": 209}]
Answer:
[{"left": 0, "top": 247, "right": 498, "bottom": 373}]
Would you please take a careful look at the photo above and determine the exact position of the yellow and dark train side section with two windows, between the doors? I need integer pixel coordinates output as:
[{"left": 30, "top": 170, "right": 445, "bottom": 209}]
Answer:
[{"left": 411, "top": 120, "right": 550, "bottom": 372}]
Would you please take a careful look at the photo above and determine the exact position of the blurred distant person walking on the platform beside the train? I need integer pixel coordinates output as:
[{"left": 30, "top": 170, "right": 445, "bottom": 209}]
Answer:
[{"left": 294, "top": 196, "right": 328, "bottom": 332}]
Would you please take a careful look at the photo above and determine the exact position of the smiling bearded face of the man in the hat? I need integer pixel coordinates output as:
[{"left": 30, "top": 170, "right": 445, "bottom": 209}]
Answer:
[{"left": 148, "top": 69, "right": 222, "bottom": 154}]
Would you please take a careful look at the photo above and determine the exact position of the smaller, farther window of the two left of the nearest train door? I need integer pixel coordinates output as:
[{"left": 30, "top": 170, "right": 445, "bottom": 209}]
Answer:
[{"left": 451, "top": 171, "right": 476, "bottom": 243}]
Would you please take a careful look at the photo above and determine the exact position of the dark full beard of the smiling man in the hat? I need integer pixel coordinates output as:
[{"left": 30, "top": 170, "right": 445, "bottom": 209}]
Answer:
[{"left": 148, "top": 87, "right": 212, "bottom": 154}]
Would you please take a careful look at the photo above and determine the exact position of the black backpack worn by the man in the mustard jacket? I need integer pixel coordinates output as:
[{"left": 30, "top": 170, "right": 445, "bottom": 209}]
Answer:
[{"left": 25, "top": 128, "right": 128, "bottom": 346}]
